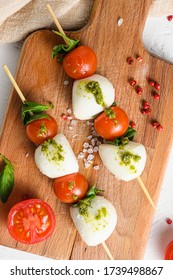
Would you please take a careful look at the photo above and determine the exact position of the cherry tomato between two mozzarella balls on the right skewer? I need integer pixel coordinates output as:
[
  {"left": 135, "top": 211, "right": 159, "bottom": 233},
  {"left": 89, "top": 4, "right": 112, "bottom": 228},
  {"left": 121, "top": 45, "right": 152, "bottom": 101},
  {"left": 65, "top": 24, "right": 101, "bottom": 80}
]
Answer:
[{"left": 94, "top": 106, "right": 129, "bottom": 140}]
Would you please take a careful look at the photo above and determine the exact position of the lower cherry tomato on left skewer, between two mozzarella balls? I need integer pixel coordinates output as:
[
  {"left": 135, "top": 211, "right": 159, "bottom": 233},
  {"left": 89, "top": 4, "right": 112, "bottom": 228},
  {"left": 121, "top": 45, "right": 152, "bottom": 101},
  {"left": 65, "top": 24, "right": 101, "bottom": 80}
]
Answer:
[{"left": 53, "top": 173, "right": 88, "bottom": 203}]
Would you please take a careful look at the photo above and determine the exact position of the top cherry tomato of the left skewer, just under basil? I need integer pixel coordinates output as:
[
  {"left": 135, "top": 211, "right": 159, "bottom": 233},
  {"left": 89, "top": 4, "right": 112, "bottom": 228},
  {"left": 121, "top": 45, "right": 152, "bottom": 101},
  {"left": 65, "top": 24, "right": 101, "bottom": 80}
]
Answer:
[{"left": 26, "top": 115, "right": 58, "bottom": 145}]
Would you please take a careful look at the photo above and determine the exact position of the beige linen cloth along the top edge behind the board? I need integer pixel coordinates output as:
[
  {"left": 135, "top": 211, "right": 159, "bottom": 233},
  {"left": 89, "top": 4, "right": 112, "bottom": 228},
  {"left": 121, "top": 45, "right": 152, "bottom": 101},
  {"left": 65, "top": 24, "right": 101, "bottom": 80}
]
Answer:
[{"left": 0, "top": 0, "right": 173, "bottom": 43}]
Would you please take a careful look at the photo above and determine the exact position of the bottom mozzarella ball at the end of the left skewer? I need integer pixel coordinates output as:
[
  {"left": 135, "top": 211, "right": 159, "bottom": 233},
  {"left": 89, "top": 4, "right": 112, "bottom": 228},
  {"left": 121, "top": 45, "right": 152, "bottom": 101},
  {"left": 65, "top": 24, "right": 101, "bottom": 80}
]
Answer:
[{"left": 70, "top": 196, "right": 117, "bottom": 246}]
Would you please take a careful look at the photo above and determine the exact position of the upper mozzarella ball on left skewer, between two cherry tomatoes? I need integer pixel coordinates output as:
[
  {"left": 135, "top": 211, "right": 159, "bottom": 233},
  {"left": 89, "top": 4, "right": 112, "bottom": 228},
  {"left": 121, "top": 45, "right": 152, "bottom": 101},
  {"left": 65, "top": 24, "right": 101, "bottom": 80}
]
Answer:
[{"left": 35, "top": 133, "right": 79, "bottom": 178}]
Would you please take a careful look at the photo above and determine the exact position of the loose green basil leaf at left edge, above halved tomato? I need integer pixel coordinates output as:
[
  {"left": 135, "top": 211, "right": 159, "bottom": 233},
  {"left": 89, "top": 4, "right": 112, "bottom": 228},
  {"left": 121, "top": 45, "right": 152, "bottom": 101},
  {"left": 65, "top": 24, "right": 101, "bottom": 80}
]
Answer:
[{"left": 0, "top": 154, "right": 14, "bottom": 203}]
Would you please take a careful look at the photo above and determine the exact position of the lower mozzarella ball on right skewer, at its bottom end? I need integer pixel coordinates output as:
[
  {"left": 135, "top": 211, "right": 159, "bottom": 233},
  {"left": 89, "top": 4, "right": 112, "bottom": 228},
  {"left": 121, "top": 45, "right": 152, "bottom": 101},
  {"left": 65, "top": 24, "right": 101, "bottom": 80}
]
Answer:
[{"left": 99, "top": 141, "right": 147, "bottom": 181}]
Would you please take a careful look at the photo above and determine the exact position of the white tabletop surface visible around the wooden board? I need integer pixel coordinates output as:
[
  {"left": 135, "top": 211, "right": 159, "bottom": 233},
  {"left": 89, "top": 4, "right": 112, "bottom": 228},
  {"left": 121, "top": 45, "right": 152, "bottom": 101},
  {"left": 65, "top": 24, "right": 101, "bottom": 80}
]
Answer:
[{"left": 0, "top": 13, "right": 173, "bottom": 260}]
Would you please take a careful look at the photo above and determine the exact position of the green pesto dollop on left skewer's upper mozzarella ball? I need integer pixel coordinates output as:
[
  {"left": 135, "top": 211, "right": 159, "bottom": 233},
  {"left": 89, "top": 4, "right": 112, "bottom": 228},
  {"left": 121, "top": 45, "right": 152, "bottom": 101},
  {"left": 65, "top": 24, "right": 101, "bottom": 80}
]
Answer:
[{"left": 41, "top": 139, "right": 64, "bottom": 164}]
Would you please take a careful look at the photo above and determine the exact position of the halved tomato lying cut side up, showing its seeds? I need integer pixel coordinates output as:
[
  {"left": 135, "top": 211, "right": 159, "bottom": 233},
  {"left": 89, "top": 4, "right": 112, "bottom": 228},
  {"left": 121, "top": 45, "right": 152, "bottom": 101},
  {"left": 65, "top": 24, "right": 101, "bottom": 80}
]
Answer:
[{"left": 7, "top": 199, "right": 55, "bottom": 244}]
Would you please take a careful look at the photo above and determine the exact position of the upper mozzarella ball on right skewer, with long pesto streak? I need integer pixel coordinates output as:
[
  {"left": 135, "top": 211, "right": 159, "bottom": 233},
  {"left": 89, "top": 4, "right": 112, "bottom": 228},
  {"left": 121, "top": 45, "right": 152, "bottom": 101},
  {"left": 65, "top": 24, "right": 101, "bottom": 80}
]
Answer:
[{"left": 72, "top": 74, "right": 115, "bottom": 120}]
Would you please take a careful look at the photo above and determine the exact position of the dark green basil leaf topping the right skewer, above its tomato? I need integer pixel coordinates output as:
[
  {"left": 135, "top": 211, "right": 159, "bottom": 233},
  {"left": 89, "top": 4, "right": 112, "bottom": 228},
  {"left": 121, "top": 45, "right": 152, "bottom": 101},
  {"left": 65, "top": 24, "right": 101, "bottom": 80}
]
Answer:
[{"left": 52, "top": 31, "right": 80, "bottom": 59}]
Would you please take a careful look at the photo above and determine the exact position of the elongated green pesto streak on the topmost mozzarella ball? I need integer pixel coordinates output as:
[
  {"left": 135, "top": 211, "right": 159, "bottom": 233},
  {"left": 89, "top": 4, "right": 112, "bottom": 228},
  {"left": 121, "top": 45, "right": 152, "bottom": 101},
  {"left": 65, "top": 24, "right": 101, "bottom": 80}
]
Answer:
[{"left": 85, "top": 81, "right": 106, "bottom": 106}]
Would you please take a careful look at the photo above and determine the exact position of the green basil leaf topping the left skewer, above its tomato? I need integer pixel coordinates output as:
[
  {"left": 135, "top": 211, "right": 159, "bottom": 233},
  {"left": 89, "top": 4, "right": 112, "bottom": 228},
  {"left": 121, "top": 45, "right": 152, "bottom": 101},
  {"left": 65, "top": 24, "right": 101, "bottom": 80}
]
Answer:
[{"left": 22, "top": 101, "right": 53, "bottom": 125}]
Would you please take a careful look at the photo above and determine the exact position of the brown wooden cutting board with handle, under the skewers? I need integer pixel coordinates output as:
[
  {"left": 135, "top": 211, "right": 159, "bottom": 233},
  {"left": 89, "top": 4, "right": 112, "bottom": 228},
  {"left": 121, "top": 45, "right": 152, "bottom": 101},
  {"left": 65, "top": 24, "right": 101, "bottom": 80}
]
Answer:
[{"left": 0, "top": 0, "right": 173, "bottom": 260}]
